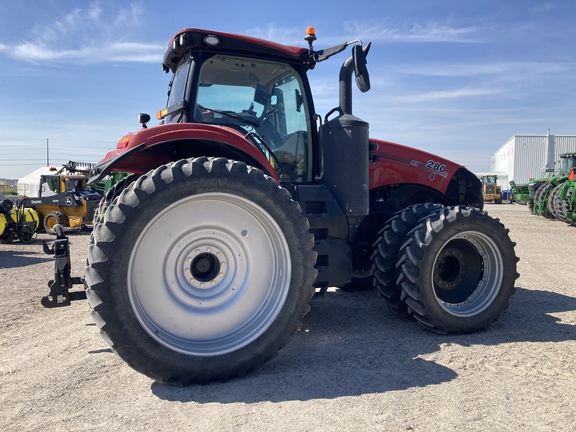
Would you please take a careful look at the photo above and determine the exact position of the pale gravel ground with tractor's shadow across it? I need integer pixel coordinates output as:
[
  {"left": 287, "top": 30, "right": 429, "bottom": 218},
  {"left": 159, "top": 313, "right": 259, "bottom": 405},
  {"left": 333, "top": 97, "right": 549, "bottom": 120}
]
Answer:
[{"left": 0, "top": 204, "right": 576, "bottom": 431}]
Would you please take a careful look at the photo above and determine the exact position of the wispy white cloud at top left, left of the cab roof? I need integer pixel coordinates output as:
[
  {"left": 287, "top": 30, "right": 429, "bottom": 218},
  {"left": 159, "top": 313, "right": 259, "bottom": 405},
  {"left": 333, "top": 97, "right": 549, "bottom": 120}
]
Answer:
[{"left": 0, "top": 1, "right": 164, "bottom": 64}]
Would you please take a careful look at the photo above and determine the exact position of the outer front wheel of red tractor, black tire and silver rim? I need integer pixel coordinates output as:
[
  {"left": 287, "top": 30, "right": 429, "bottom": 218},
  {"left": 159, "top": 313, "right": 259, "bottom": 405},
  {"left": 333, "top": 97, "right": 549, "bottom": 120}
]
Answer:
[{"left": 399, "top": 206, "right": 519, "bottom": 333}]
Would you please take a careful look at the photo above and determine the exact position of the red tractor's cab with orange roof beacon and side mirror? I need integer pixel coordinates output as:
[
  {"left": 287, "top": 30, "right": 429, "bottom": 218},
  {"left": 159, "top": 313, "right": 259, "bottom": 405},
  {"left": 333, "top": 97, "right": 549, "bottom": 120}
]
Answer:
[{"left": 145, "top": 28, "right": 369, "bottom": 183}]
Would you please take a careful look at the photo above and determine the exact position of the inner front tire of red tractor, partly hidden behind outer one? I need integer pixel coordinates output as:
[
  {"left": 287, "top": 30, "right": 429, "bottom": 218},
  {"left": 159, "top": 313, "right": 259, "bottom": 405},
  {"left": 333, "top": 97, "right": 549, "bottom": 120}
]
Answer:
[{"left": 372, "top": 203, "right": 444, "bottom": 313}]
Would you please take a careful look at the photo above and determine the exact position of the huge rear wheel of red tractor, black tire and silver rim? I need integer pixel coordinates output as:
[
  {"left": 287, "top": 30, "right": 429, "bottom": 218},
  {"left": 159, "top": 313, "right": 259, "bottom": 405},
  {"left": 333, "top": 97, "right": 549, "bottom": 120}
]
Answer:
[{"left": 86, "top": 158, "right": 316, "bottom": 385}]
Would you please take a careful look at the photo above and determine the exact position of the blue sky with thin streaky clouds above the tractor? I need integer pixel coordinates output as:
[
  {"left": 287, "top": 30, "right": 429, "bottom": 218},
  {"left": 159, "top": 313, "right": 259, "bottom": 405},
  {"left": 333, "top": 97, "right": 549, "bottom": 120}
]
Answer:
[{"left": 0, "top": 0, "right": 576, "bottom": 178}]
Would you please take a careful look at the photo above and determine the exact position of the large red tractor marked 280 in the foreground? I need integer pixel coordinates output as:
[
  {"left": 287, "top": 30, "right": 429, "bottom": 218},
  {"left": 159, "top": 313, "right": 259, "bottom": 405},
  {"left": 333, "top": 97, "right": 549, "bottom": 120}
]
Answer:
[{"left": 85, "top": 28, "right": 518, "bottom": 385}]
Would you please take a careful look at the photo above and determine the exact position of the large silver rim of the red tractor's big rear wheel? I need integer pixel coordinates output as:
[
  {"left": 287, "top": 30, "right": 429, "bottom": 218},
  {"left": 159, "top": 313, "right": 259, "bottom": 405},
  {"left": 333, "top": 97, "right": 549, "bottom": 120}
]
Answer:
[{"left": 127, "top": 192, "right": 291, "bottom": 356}]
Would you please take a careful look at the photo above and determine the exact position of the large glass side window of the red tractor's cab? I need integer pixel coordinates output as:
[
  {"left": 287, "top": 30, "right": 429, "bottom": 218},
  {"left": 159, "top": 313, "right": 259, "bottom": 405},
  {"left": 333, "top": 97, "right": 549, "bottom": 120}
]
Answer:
[{"left": 192, "top": 55, "right": 312, "bottom": 182}]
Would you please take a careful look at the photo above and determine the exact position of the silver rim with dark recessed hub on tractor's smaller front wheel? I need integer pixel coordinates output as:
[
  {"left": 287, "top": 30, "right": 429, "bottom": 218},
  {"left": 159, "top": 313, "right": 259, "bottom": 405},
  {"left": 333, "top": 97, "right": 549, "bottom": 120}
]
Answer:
[{"left": 431, "top": 231, "right": 504, "bottom": 317}]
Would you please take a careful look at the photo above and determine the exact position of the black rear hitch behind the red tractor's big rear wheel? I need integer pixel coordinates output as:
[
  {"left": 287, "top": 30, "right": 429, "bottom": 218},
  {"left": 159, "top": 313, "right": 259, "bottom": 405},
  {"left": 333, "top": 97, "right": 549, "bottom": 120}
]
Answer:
[{"left": 40, "top": 224, "right": 86, "bottom": 308}]
